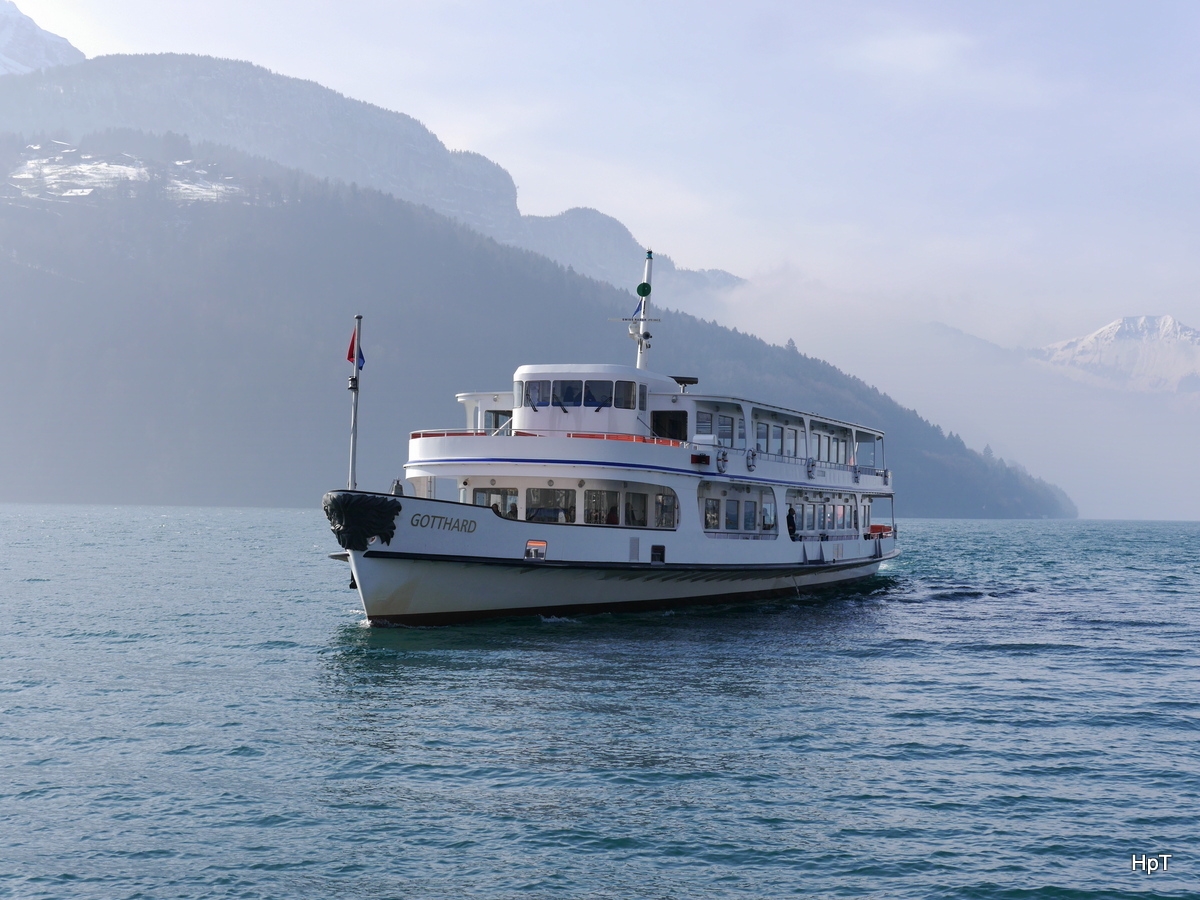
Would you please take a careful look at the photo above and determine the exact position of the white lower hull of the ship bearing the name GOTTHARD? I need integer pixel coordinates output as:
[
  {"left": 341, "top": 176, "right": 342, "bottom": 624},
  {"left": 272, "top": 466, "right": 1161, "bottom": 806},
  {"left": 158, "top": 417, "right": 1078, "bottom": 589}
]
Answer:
[{"left": 324, "top": 492, "right": 896, "bottom": 625}]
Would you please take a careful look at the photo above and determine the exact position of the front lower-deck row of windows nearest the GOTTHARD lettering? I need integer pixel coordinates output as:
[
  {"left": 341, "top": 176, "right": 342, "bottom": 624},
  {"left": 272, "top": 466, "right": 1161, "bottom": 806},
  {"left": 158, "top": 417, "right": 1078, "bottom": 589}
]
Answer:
[{"left": 472, "top": 487, "right": 679, "bottom": 528}]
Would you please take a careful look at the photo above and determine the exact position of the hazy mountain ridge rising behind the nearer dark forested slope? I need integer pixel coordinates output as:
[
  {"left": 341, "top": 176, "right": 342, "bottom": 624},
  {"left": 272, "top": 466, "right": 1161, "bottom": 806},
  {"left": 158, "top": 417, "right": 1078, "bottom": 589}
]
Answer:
[{"left": 0, "top": 54, "right": 740, "bottom": 305}]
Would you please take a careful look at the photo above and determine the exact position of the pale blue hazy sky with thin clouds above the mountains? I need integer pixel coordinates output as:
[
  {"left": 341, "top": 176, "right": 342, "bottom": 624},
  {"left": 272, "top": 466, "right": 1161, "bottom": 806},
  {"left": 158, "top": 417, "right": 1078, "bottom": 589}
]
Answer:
[{"left": 17, "top": 0, "right": 1200, "bottom": 355}]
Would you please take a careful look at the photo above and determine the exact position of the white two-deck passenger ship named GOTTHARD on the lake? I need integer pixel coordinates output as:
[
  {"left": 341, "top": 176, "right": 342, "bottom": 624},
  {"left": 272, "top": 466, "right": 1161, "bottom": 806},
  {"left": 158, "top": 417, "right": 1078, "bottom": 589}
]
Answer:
[{"left": 323, "top": 253, "right": 899, "bottom": 625}]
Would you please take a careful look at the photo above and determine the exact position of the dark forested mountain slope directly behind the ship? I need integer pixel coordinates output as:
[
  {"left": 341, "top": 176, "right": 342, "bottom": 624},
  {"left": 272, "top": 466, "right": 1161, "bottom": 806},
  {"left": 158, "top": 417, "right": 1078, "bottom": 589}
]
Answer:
[{"left": 0, "top": 131, "right": 1074, "bottom": 517}]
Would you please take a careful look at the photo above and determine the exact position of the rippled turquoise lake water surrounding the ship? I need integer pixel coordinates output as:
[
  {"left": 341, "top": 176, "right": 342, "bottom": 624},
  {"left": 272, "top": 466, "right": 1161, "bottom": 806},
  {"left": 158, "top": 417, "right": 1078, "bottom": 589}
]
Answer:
[{"left": 0, "top": 505, "right": 1200, "bottom": 899}]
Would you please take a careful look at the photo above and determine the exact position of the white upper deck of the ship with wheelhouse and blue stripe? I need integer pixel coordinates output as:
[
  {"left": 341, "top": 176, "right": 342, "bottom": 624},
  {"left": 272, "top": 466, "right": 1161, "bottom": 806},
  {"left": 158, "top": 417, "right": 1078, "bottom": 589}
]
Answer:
[{"left": 408, "top": 365, "right": 890, "bottom": 493}]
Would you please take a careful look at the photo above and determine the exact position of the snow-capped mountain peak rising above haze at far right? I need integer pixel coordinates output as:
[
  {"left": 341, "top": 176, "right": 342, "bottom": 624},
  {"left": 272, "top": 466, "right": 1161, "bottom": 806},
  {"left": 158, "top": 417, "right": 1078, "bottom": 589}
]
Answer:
[{"left": 1033, "top": 316, "right": 1200, "bottom": 392}]
